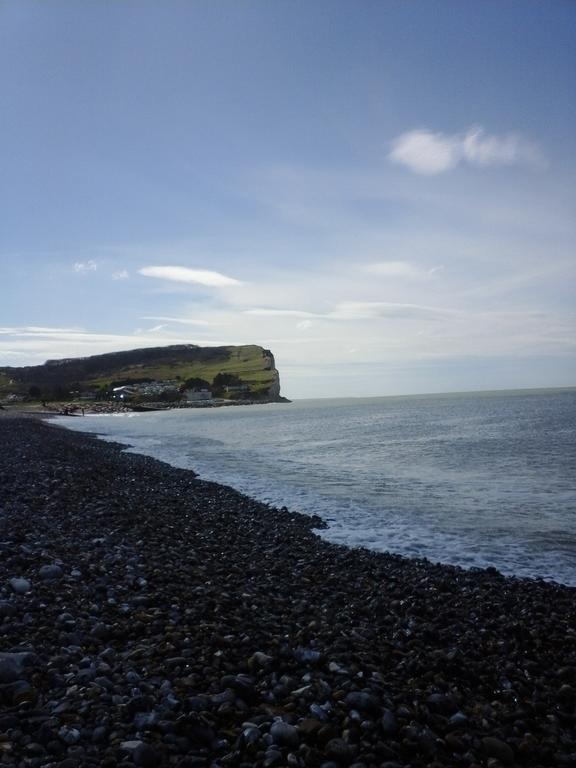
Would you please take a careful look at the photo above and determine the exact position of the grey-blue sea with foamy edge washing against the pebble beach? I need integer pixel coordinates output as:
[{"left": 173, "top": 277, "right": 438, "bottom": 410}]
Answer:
[{"left": 58, "top": 390, "right": 576, "bottom": 586}]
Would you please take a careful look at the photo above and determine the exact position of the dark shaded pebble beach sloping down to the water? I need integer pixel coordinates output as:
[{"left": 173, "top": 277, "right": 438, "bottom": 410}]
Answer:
[{"left": 0, "top": 419, "right": 576, "bottom": 768}]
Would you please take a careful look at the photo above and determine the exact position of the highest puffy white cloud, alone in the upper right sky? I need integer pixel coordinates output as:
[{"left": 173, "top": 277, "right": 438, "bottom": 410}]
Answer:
[{"left": 388, "top": 126, "right": 544, "bottom": 175}]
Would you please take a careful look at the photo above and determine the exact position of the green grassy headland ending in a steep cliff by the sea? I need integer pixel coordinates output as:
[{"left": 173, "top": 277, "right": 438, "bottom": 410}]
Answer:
[{"left": 0, "top": 344, "right": 280, "bottom": 400}]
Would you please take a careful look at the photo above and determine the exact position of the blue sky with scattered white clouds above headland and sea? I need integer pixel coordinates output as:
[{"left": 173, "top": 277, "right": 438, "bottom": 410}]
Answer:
[{"left": 0, "top": 0, "right": 576, "bottom": 398}]
